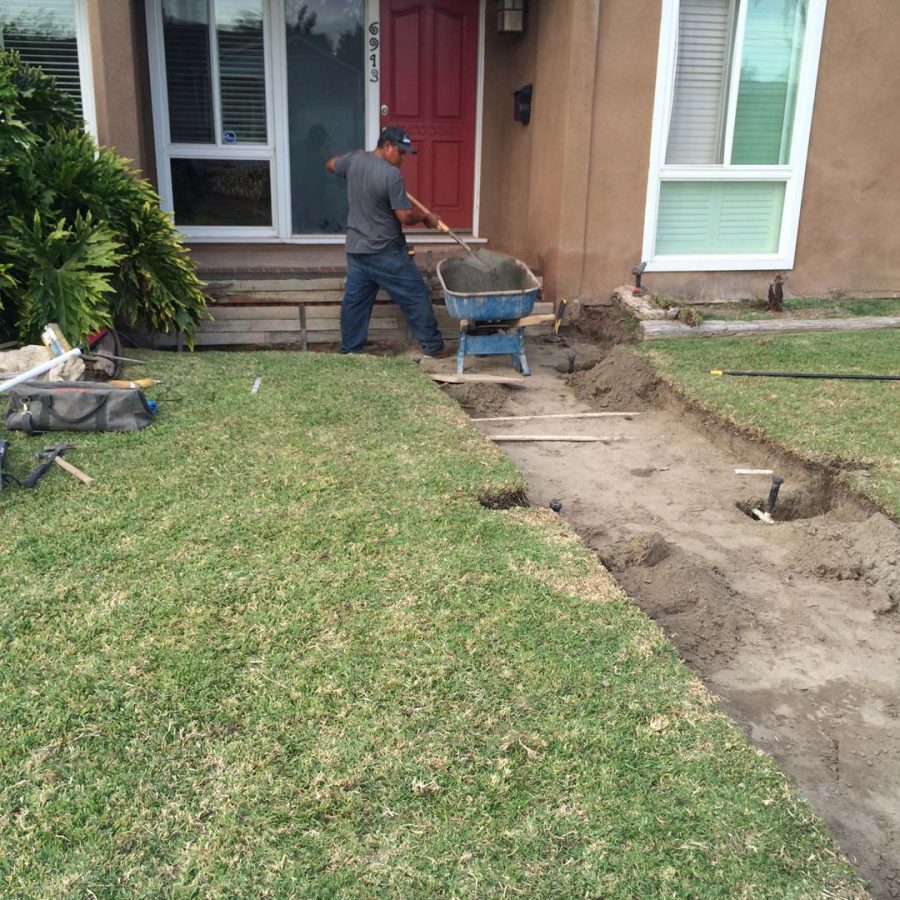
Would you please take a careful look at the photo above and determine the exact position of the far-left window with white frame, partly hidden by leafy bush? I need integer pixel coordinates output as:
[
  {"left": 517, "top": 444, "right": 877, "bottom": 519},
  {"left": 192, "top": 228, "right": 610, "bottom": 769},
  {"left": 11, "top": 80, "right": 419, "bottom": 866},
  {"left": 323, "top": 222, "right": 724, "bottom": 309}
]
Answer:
[{"left": 0, "top": 0, "right": 97, "bottom": 136}]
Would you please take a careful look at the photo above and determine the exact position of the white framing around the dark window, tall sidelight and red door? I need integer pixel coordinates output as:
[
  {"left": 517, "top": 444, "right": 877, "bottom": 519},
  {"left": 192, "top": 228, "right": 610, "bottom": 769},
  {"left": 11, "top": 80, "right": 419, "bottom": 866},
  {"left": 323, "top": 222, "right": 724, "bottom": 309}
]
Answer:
[{"left": 148, "top": 0, "right": 486, "bottom": 245}]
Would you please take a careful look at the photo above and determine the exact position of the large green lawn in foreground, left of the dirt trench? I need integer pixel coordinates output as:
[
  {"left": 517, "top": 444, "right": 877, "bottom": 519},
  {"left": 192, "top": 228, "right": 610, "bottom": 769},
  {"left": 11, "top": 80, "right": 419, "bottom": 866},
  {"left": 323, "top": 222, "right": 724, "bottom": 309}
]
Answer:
[{"left": 0, "top": 353, "right": 862, "bottom": 898}]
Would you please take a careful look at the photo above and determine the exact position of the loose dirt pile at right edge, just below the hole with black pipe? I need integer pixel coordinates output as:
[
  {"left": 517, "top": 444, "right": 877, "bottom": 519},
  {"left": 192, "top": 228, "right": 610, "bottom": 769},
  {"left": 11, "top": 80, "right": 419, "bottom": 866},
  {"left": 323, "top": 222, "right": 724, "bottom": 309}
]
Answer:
[{"left": 797, "top": 513, "right": 900, "bottom": 615}]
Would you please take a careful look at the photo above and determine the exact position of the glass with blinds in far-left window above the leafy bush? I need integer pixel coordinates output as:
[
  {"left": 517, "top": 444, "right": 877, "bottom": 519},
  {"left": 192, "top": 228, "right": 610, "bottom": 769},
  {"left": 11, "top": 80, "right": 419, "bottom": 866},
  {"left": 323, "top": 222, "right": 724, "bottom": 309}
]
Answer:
[{"left": 0, "top": 0, "right": 82, "bottom": 113}]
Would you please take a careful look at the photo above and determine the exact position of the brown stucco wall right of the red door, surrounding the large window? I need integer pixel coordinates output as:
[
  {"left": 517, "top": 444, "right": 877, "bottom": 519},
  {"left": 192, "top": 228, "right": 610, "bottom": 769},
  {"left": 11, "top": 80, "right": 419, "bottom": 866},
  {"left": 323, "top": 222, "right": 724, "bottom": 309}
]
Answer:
[{"left": 480, "top": 0, "right": 900, "bottom": 300}]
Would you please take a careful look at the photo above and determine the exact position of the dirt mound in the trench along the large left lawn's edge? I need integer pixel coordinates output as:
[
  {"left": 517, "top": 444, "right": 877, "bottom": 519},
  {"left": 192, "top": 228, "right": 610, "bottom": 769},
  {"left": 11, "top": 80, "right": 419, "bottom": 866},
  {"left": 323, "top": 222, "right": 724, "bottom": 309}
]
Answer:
[{"left": 590, "top": 533, "right": 753, "bottom": 666}]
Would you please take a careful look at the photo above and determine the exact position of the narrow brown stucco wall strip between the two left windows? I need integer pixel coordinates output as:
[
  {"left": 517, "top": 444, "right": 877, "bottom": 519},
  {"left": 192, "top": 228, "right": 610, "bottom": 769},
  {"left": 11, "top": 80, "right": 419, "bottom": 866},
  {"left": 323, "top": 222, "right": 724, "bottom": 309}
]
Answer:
[{"left": 88, "top": 0, "right": 155, "bottom": 176}]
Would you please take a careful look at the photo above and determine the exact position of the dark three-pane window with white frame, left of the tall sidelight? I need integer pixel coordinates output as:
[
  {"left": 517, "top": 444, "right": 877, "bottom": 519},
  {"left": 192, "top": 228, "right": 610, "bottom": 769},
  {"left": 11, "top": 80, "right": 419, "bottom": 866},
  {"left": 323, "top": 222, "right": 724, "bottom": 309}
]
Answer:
[{"left": 148, "top": 0, "right": 275, "bottom": 236}]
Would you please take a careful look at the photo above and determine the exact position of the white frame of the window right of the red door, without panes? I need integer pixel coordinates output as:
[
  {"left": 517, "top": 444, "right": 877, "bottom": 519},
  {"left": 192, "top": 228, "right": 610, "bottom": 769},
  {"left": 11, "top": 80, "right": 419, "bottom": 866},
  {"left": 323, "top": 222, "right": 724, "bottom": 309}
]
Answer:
[{"left": 642, "top": 0, "right": 827, "bottom": 272}]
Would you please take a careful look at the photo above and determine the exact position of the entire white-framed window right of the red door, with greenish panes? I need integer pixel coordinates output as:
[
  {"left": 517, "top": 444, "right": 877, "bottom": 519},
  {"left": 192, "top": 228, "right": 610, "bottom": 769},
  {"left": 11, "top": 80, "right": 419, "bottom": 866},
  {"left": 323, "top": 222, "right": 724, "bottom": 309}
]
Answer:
[{"left": 644, "top": 0, "right": 825, "bottom": 271}]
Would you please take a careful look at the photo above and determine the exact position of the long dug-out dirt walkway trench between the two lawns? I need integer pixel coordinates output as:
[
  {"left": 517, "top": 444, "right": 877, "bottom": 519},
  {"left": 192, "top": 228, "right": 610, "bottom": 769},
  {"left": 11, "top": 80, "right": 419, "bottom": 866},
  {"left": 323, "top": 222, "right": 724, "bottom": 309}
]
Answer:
[{"left": 432, "top": 312, "right": 900, "bottom": 900}]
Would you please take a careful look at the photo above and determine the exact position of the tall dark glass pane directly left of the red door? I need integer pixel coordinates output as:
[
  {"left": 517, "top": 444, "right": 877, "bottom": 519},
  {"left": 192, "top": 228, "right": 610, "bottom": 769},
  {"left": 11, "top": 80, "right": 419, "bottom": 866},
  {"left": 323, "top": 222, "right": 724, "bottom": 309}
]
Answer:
[{"left": 286, "top": 0, "right": 366, "bottom": 234}]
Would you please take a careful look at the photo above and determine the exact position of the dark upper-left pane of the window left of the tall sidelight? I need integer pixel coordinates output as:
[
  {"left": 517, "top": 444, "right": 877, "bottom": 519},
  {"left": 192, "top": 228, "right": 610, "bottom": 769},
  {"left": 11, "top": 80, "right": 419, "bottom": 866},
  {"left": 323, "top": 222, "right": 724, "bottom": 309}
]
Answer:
[{"left": 163, "top": 0, "right": 216, "bottom": 144}]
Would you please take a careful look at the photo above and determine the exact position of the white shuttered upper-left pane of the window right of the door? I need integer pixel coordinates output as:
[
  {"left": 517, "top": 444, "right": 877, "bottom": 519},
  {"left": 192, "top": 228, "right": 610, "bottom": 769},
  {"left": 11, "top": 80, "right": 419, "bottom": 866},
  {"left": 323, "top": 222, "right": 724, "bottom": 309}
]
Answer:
[{"left": 666, "top": 0, "right": 734, "bottom": 165}]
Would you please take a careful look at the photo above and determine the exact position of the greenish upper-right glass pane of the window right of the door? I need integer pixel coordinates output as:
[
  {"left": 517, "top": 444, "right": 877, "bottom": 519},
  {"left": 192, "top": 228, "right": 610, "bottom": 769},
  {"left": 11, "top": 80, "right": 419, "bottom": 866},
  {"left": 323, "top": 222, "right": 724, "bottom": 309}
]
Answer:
[{"left": 731, "top": 0, "right": 808, "bottom": 165}]
